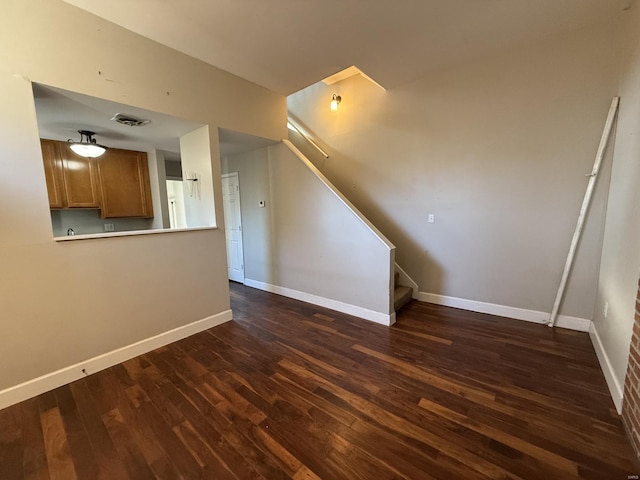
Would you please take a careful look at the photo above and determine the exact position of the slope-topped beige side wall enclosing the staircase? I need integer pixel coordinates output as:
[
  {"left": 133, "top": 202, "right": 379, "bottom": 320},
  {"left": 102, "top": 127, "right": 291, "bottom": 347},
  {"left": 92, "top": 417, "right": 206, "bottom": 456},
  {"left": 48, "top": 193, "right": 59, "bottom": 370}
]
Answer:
[{"left": 269, "top": 144, "right": 394, "bottom": 314}]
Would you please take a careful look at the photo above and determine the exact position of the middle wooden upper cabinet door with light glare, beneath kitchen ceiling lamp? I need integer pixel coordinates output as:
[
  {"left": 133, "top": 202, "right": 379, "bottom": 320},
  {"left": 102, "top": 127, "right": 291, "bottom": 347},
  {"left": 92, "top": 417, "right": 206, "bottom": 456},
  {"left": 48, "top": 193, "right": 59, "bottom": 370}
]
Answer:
[{"left": 57, "top": 142, "right": 100, "bottom": 208}]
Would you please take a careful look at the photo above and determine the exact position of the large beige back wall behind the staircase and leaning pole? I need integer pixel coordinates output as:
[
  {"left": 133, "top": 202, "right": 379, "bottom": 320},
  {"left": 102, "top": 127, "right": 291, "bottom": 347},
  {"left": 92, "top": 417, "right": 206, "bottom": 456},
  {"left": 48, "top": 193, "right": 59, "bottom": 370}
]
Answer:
[{"left": 288, "top": 17, "right": 618, "bottom": 319}]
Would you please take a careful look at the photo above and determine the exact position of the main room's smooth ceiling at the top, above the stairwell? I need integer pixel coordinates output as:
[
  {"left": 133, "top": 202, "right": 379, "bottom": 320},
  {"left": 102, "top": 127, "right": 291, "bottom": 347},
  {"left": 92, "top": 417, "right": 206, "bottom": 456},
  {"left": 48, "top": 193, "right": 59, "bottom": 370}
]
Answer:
[{"left": 65, "top": 0, "right": 632, "bottom": 95}]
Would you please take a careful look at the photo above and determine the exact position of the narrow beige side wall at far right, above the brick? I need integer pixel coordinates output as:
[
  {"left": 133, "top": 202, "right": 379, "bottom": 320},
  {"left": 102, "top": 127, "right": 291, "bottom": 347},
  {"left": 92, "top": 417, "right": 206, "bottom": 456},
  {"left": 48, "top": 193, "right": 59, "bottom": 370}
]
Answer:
[{"left": 594, "top": 3, "right": 640, "bottom": 402}]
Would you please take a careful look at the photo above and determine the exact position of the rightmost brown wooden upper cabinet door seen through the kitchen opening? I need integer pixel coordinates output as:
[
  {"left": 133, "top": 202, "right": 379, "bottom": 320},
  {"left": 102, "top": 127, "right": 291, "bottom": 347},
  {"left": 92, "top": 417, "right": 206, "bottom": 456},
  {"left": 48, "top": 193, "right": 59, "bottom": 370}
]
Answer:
[{"left": 96, "top": 148, "right": 153, "bottom": 218}]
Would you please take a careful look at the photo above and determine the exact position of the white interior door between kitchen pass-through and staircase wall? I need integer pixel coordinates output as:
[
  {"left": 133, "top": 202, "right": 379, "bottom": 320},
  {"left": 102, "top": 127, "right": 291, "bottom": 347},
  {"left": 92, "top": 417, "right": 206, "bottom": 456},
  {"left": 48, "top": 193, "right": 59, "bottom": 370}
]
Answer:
[{"left": 222, "top": 172, "right": 244, "bottom": 283}]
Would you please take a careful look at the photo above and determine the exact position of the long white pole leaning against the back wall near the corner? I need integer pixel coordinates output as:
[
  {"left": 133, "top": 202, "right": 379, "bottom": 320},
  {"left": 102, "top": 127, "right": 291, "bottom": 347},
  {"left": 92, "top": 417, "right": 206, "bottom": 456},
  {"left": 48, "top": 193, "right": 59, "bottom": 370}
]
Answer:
[{"left": 549, "top": 97, "right": 620, "bottom": 327}]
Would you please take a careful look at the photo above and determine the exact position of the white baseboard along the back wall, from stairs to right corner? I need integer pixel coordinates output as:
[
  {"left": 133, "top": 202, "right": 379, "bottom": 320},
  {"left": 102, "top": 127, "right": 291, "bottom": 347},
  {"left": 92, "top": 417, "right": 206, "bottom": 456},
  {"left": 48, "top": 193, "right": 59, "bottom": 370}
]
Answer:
[{"left": 417, "top": 292, "right": 591, "bottom": 332}]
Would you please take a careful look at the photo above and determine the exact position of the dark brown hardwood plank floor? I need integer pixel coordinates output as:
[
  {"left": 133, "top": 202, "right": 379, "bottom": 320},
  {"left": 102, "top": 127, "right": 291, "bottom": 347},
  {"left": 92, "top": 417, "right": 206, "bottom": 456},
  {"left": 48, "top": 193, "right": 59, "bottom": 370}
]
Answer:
[{"left": 0, "top": 284, "right": 640, "bottom": 480}]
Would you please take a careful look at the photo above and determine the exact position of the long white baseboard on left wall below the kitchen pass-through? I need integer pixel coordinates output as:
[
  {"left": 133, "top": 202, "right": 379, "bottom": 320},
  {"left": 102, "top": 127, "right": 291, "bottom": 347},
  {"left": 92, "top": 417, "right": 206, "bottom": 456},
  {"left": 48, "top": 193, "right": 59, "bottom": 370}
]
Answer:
[{"left": 0, "top": 310, "right": 233, "bottom": 409}]
